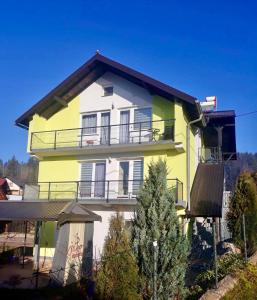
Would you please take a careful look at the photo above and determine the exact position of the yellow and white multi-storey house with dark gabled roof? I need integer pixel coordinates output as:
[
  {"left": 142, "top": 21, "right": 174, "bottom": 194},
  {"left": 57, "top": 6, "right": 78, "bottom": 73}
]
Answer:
[{"left": 12, "top": 53, "right": 236, "bottom": 282}]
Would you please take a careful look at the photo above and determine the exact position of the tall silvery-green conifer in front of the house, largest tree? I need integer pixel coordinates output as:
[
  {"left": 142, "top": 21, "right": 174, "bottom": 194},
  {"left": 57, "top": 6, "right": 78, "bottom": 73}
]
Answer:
[{"left": 132, "top": 160, "right": 189, "bottom": 299}]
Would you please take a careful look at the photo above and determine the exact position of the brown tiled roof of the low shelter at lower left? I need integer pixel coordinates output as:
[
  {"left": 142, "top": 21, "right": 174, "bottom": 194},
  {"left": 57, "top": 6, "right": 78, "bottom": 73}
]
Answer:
[{"left": 0, "top": 200, "right": 101, "bottom": 223}]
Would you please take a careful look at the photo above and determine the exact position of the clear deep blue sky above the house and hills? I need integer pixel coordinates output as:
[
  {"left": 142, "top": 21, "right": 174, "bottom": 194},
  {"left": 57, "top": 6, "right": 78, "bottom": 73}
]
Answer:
[{"left": 0, "top": 0, "right": 257, "bottom": 160}]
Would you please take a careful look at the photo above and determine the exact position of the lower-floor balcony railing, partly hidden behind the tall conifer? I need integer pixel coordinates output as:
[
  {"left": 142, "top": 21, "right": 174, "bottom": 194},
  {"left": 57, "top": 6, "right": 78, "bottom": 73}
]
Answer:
[{"left": 38, "top": 179, "right": 183, "bottom": 202}]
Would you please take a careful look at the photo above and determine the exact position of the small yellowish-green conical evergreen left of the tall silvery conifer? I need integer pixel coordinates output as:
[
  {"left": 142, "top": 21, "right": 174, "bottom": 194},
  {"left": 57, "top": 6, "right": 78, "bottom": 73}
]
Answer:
[{"left": 96, "top": 213, "right": 141, "bottom": 300}]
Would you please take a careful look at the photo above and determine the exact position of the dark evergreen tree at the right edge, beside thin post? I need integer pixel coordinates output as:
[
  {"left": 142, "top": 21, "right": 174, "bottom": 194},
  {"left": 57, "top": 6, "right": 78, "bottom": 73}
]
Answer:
[{"left": 227, "top": 172, "right": 257, "bottom": 255}]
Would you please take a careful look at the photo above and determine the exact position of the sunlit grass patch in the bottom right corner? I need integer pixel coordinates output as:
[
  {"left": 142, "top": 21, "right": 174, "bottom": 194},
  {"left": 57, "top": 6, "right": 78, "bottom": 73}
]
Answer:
[{"left": 222, "top": 264, "right": 257, "bottom": 300}]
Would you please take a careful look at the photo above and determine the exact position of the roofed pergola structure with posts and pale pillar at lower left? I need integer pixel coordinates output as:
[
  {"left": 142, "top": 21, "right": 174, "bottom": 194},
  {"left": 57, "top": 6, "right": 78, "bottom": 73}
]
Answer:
[{"left": 0, "top": 200, "right": 101, "bottom": 286}]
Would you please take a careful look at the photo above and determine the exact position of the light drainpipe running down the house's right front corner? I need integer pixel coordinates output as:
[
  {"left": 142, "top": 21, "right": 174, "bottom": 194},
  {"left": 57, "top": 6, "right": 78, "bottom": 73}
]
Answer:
[{"left": 186, "top": 101, "right": 206, "bottom": 211}]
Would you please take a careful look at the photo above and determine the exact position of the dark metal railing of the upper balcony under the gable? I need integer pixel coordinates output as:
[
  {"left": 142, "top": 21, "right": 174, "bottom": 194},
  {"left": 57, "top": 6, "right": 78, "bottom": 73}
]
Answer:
[{"left": 30, "top": 119, "right": 175, "bottom": 151}]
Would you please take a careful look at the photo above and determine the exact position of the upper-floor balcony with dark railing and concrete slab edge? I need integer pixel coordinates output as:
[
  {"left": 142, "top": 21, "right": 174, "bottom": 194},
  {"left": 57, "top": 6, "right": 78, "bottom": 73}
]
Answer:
[{"left": 30, "top": 119, "right": 175, "bottom": 155}]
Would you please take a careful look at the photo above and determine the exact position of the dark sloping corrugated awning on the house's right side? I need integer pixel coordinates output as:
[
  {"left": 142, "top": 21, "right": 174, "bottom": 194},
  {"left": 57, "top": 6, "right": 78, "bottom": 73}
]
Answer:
[{"left": 187, "top": 163, "right": 224, "bottom": 218}]
